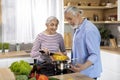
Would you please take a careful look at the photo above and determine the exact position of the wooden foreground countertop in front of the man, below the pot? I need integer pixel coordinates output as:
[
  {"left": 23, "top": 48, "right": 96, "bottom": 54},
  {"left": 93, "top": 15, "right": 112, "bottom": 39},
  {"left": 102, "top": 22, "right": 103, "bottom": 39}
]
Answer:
[{"left": 52, "top": 73, "right": 94, "bottom": 80}]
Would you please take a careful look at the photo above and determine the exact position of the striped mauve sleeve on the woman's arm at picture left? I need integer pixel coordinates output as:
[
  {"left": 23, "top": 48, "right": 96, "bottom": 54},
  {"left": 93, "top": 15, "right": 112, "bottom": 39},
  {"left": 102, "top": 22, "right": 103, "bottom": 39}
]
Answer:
[{"left": 30, "top": 35, "right": 41, "bottom": 58}]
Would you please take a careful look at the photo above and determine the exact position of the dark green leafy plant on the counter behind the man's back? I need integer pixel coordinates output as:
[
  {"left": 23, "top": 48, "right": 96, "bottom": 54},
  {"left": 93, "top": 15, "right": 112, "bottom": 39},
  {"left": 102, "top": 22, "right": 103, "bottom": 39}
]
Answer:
[{"left": 98, "top": 26, "right": 111, "bottom": 46}]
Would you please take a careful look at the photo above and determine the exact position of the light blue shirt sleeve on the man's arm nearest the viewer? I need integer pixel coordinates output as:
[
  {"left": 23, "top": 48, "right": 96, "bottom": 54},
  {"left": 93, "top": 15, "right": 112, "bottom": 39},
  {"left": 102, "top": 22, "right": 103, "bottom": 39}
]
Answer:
[{"left": 86, "top": 31, "right": 100, "bottom": 64}]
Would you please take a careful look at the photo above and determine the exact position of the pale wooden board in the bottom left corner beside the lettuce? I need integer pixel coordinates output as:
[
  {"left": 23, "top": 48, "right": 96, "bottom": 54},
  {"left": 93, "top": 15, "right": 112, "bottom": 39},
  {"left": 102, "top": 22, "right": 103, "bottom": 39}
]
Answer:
[{"left": 0, "top": 68, "right": 15, "bottom": 80}]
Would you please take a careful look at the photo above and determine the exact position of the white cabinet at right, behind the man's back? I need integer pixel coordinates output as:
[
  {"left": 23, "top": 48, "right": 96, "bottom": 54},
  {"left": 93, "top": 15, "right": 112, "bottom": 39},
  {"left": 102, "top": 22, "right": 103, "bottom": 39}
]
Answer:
[{"left": 100, "top": 50, "right": 120, "bottom": 80}]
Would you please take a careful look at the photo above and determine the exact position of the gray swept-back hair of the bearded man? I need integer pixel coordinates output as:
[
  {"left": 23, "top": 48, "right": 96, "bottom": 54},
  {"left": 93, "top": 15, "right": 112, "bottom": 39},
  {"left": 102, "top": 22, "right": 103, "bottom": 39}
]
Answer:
[{"left": 64, "top": 6, "right": 83, "bottom": 16}]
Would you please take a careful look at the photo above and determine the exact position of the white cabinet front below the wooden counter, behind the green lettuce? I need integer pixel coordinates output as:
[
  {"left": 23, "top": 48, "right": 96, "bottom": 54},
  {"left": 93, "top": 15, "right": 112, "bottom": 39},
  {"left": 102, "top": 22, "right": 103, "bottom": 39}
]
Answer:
[{"left": 0, "top": 57, "right": 34, "bottom": 68}]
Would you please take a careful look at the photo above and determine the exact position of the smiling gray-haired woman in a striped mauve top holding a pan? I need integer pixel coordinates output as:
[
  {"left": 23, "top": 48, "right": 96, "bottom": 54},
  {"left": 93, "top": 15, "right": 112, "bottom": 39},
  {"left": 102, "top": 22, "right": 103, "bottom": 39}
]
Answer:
[{"left": 30, "top": 16, "right": 66, "bottom": 62}]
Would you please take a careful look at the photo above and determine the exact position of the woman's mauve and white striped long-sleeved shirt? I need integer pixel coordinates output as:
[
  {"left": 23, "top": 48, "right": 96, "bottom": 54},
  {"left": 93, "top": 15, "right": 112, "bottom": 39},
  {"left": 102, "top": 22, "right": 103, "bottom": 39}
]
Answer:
[{"left": 30, "top": 33, "right": 65, "bottom": 61}]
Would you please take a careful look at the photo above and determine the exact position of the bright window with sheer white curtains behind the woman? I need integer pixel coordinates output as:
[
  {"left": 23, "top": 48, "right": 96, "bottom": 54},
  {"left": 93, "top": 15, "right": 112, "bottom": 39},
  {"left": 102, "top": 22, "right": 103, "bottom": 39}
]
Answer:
[{"left": 2, "top": 0, "right": 64, "bottom": 43}]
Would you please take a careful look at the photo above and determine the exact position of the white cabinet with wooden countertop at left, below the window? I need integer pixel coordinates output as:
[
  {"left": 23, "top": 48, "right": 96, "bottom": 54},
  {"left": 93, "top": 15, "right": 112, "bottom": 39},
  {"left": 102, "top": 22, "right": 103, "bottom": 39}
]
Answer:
[{"left": 0, "top": 51, "right": 34, "bottom": 68}]
